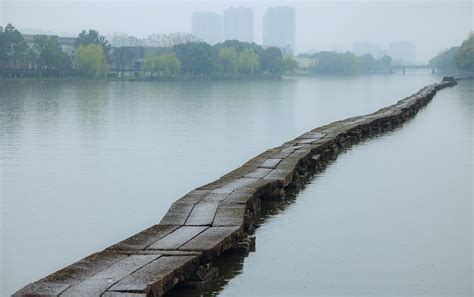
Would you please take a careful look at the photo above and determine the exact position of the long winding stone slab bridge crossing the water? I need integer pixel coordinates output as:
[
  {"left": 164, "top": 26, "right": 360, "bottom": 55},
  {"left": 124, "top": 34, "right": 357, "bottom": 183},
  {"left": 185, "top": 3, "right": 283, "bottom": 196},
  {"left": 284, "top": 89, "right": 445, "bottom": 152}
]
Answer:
[{"left": 14, "top": 78, "right": 456, "bottom": 297}]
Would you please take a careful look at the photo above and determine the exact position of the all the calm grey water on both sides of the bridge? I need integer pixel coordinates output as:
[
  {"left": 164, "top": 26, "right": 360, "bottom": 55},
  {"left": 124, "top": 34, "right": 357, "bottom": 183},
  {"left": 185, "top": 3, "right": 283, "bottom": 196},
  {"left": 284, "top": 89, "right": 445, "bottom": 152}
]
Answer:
[{"left": 0, "top": 73, "right": 474, "bottom": 297}]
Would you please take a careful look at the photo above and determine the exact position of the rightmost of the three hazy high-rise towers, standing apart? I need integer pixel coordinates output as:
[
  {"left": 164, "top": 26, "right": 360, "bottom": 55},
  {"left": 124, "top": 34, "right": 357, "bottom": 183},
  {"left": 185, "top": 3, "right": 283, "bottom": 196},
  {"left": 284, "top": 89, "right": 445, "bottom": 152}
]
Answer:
[{"left": 263, "top": 7, "right": 295, "bottom": 52}]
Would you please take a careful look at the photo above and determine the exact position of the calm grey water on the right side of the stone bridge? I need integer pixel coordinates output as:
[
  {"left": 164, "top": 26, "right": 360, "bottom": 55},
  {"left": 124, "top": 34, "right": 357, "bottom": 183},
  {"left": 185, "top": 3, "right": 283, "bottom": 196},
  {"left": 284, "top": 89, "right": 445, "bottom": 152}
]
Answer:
[{"left": 172, "top": 81, "right": 474, "bottom": 297}]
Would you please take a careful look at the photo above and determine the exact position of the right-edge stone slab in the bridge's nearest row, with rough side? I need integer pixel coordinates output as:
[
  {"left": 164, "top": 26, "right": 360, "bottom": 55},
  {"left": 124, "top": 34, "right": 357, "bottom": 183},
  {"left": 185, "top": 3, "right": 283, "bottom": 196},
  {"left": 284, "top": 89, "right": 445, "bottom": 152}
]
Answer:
[{"left": 109, "top": 256, "right": 199, "bottom": 296}]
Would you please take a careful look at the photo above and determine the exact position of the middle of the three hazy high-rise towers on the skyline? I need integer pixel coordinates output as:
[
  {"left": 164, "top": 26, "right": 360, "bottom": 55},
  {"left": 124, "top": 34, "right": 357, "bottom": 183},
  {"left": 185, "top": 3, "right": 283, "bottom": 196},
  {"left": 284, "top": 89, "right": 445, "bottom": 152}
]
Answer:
[{"left": 224, "top": 7, "right": 253, "bottom": 42}]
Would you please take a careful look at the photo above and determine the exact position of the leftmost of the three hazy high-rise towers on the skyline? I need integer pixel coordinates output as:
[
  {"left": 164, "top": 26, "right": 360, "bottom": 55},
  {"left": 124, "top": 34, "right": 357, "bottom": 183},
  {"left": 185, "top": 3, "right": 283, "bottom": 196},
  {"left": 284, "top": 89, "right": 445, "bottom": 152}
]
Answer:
[{"left": 192, "top": 12, "right": 224, "bottom": 44}]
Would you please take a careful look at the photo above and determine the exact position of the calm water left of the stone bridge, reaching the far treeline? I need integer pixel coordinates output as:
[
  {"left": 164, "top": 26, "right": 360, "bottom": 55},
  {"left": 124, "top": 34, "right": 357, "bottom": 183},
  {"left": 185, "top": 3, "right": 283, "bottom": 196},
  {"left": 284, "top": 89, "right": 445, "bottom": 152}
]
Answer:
[{"left": 0, "top": 74, "right": 448, "bottom": 295}]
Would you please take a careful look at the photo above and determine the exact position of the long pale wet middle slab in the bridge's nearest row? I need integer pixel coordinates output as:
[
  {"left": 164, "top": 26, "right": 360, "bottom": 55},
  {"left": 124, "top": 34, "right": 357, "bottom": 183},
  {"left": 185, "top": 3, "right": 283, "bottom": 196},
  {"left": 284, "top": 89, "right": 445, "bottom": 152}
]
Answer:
[{"left": 61, "top": 255, "right": 160, "bottom": 296}]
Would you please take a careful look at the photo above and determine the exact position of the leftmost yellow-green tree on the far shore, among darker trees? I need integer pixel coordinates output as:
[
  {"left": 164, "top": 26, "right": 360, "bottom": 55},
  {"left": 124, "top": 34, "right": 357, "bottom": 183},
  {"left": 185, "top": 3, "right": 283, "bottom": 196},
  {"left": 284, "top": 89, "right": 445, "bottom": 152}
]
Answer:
[{"left": 75, "top": 44, "right": 109, "bottom": 78}]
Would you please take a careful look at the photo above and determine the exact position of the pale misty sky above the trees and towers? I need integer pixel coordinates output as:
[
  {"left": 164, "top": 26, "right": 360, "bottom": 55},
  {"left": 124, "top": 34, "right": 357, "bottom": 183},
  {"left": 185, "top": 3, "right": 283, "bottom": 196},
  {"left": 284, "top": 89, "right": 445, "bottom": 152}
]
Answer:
[{"left": 0, "top": 0, "right": 474, "bottom": 62}]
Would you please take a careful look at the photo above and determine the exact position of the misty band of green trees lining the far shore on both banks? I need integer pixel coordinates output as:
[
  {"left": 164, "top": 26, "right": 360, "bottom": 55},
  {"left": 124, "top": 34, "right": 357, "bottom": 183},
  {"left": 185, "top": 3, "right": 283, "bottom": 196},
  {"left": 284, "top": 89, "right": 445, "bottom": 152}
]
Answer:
[{"left": 0, "top": 24, "right": 474, "bottom": 81}]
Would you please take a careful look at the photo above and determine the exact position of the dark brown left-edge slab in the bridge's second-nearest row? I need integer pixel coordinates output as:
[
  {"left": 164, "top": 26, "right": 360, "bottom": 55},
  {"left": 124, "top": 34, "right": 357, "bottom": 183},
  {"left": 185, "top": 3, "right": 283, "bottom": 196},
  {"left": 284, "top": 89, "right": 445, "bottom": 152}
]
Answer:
[{"left": 107, "top": 225, "right": 179, "bottom": 251}]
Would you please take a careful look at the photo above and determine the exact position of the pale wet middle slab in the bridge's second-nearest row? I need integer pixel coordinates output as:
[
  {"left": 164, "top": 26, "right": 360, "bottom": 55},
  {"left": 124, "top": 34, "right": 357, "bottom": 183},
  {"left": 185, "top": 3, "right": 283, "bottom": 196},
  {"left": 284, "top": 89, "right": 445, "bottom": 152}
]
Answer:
[{"left": 148, "top": 226, "right": 208, "bottom": 250}]
